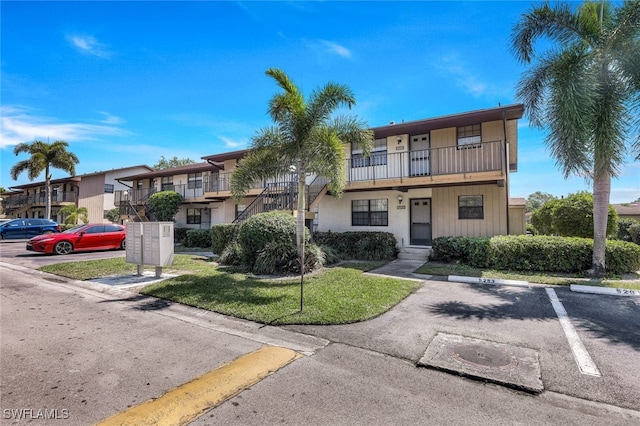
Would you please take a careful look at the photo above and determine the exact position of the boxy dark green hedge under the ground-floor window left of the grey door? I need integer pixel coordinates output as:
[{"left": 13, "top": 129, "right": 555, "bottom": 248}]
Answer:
[{"left": 313, "top": 231, "right": 397, "bottom": 260}]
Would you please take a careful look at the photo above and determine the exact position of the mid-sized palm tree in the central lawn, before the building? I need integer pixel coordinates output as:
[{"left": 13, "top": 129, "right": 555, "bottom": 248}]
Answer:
[{"left": 231, "top": 68, "right": 373, "bottom": 310}]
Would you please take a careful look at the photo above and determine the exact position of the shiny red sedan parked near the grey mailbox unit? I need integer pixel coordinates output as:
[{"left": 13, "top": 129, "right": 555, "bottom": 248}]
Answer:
[{"left": 27, "top": 223, "right": 126, "bottom": 254}]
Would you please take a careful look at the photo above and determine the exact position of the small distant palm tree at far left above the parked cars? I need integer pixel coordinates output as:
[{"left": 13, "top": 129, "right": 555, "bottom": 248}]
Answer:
[{"left": 11, "top": 141, "right": 79, "bottom": 219}]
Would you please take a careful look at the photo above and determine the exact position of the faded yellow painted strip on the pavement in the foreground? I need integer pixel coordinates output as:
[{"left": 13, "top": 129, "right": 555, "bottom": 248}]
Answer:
[{"left": 97, "top": 346, "right": 302, "bottom": 426}]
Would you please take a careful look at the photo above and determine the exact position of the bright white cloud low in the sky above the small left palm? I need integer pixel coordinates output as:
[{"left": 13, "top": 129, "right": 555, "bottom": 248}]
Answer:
[{"left": 0, "top": 106, "right": 129, "bottom": 148}]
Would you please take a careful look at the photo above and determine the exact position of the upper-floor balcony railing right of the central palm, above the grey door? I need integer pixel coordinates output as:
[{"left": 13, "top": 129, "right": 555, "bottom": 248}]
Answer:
[{"left": 346, "top": 141, "right": 504, "bottom": 182}]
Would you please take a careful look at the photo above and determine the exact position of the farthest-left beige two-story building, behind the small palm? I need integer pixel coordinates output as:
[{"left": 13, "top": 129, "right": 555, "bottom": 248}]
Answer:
[{"left": 2, "top": 165, "right": 153, "bottom": 223}]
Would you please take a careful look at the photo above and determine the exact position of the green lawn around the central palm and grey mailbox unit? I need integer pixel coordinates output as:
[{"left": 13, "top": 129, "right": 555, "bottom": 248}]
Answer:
[{"left": 40, "top": 255, "right": 419, "bottom": 325}]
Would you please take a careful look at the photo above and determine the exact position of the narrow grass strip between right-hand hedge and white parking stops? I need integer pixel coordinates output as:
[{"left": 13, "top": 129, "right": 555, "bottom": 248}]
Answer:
[{"left": 415, "top": 262, "right": 640, "bottom": 290}]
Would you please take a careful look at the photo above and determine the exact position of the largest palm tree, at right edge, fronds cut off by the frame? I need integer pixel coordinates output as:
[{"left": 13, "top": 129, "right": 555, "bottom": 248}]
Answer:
[{"left": 511, "top": 0, "right": 640, "bottom": 276}]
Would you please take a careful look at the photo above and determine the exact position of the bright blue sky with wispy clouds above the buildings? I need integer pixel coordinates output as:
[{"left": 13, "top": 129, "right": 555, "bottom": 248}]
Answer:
[{"left": 0, "top": 1, "right": 640, "bottom": 203}]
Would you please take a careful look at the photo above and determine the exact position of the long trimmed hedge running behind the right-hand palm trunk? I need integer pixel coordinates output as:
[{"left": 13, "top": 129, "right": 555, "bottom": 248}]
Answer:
[{"left": 432, "top": 235, "right": 640, "bottom": 274}]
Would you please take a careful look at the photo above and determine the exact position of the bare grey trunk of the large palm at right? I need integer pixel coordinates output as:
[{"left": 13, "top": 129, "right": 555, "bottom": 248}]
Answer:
[{"left": 591, "top": 165, "right": 611, "bottom": 277}]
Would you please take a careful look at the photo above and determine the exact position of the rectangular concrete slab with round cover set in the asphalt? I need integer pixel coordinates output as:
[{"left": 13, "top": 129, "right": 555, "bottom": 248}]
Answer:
[{"left": 418, "top": 333, "right": 544, "bottom": 393}]
